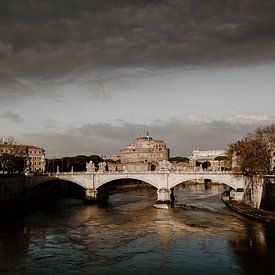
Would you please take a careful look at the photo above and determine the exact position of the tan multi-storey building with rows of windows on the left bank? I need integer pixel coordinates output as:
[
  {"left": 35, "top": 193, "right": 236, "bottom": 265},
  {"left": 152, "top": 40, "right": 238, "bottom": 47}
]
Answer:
[{"left": 0, "top": 142, "right": 46, "bottom": 172}]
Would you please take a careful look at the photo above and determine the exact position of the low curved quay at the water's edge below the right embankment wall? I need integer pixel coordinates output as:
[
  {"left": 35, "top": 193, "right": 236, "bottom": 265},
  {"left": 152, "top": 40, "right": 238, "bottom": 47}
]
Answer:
[{"left": 221, "top": 194, "right": 275, "bottom": 223}]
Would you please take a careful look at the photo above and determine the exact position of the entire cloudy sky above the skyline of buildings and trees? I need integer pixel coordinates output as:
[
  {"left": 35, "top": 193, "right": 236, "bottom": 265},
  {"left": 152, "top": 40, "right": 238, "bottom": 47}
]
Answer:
[{"left": 0, "top": 0, "right": 275, "bottom": 156}]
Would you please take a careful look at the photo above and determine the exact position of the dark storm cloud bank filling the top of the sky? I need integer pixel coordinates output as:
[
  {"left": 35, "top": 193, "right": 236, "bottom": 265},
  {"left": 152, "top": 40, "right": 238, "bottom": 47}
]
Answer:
[{"left": 0, "top": 0, "right": 275, "bottom": 100}]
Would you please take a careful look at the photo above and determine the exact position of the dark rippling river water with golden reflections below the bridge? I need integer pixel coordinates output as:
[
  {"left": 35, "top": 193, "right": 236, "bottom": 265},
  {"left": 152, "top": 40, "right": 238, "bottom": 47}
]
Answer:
[{"left": 0, "top": 184, "right": 275, "bottom": 274}]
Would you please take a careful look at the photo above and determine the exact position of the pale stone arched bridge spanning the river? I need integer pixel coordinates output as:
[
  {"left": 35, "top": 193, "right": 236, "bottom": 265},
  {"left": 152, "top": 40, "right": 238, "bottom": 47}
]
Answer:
[{"left": 30, "top": 171, "right": 245, "bottom": 203}]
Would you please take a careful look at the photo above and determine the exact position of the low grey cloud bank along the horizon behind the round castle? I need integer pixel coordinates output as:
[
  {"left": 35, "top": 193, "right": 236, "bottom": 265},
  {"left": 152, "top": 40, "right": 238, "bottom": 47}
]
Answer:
[{"left": 18, "top": 116, "right": 274, "bottom": 156}]
